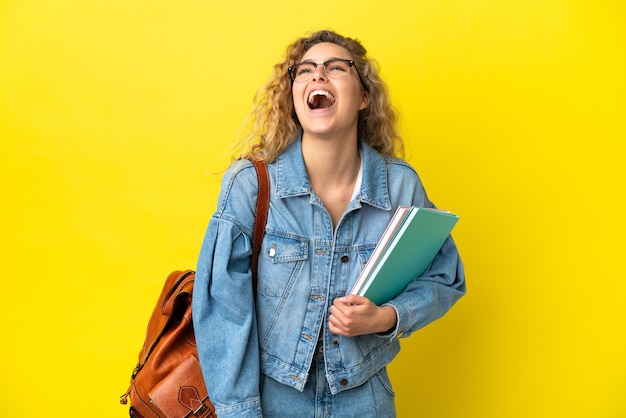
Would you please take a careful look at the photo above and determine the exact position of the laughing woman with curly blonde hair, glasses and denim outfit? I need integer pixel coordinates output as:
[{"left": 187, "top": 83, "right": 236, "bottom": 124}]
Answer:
[{"left": 193, "top": 31, "right": 465, "bottom": 418}]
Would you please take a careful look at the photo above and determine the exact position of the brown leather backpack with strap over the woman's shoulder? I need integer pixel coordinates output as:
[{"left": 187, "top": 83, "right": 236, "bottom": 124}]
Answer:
[{"left": 120, "top": 161, "right": 269, "bottom": 418}]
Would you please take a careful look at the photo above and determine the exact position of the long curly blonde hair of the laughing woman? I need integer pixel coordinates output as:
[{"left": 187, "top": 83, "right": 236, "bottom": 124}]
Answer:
[{"left": 232, "top": 30, "right": 404, "bottom": 162}]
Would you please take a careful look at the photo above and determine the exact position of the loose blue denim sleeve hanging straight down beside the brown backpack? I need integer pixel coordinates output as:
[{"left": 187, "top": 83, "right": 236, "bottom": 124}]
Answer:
[{"left": 192, "top": 163, "right": 262, "bottom": 418}]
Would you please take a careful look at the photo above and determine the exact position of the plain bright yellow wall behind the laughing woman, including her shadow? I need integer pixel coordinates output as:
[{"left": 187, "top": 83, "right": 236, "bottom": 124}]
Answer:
[{"left": 0, "top": 0, "right": 626, "bottom": 418}]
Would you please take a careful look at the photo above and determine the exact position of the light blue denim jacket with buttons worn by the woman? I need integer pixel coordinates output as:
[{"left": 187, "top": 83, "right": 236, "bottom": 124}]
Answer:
[{"left": 193, "top": 137, "right": 465, "bottom": 418}]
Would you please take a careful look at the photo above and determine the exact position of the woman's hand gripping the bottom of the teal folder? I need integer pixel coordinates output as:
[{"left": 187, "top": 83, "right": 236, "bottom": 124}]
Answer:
[{"left": 328, "top": 295, "right": 398, "bottom": 337}]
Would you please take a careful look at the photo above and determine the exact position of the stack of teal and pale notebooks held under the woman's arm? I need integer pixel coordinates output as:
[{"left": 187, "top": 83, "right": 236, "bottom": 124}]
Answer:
[{"left": 350, "top": 206, "right": 459, "bottom": 305}]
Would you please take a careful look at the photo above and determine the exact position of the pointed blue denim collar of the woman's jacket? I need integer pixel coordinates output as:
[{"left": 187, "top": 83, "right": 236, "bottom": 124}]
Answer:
[{"left": 276, "top": 132, "right": 391, "bottom": 210}]
